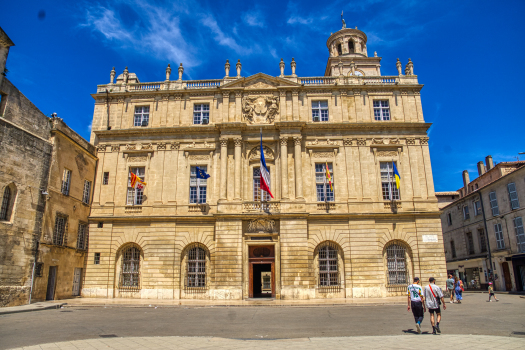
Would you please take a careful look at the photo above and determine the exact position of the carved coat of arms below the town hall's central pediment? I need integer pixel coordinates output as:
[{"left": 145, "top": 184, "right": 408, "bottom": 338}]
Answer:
[{"left": 242, "top": 96, "right": 279, "bottom": 124}]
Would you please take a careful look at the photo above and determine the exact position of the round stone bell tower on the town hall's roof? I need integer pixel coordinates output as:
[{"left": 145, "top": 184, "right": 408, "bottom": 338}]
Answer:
[{"left": 324, "top": 16, "right": 381, "bottom": 76}]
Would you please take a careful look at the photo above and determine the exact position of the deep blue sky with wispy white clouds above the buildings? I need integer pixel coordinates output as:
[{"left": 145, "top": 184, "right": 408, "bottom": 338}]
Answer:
[{"left": 0, "top": 0, "right": 525, "bottom": 191}]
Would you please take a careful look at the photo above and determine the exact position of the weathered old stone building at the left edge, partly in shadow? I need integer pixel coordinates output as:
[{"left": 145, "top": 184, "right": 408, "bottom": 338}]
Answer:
[{"left": 0, "top": 28, "right": 97, "bottom": 306}]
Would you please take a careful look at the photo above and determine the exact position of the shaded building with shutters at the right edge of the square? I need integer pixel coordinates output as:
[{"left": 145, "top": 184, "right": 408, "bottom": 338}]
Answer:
[{"left": 441, "top": 156, "right": 525, "bottom": 291}]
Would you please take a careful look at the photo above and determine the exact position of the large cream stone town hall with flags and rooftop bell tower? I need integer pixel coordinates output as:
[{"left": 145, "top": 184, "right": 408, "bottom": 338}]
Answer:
[{"left": 82, "top": 23, "right": 446, "bottom": 299}]
